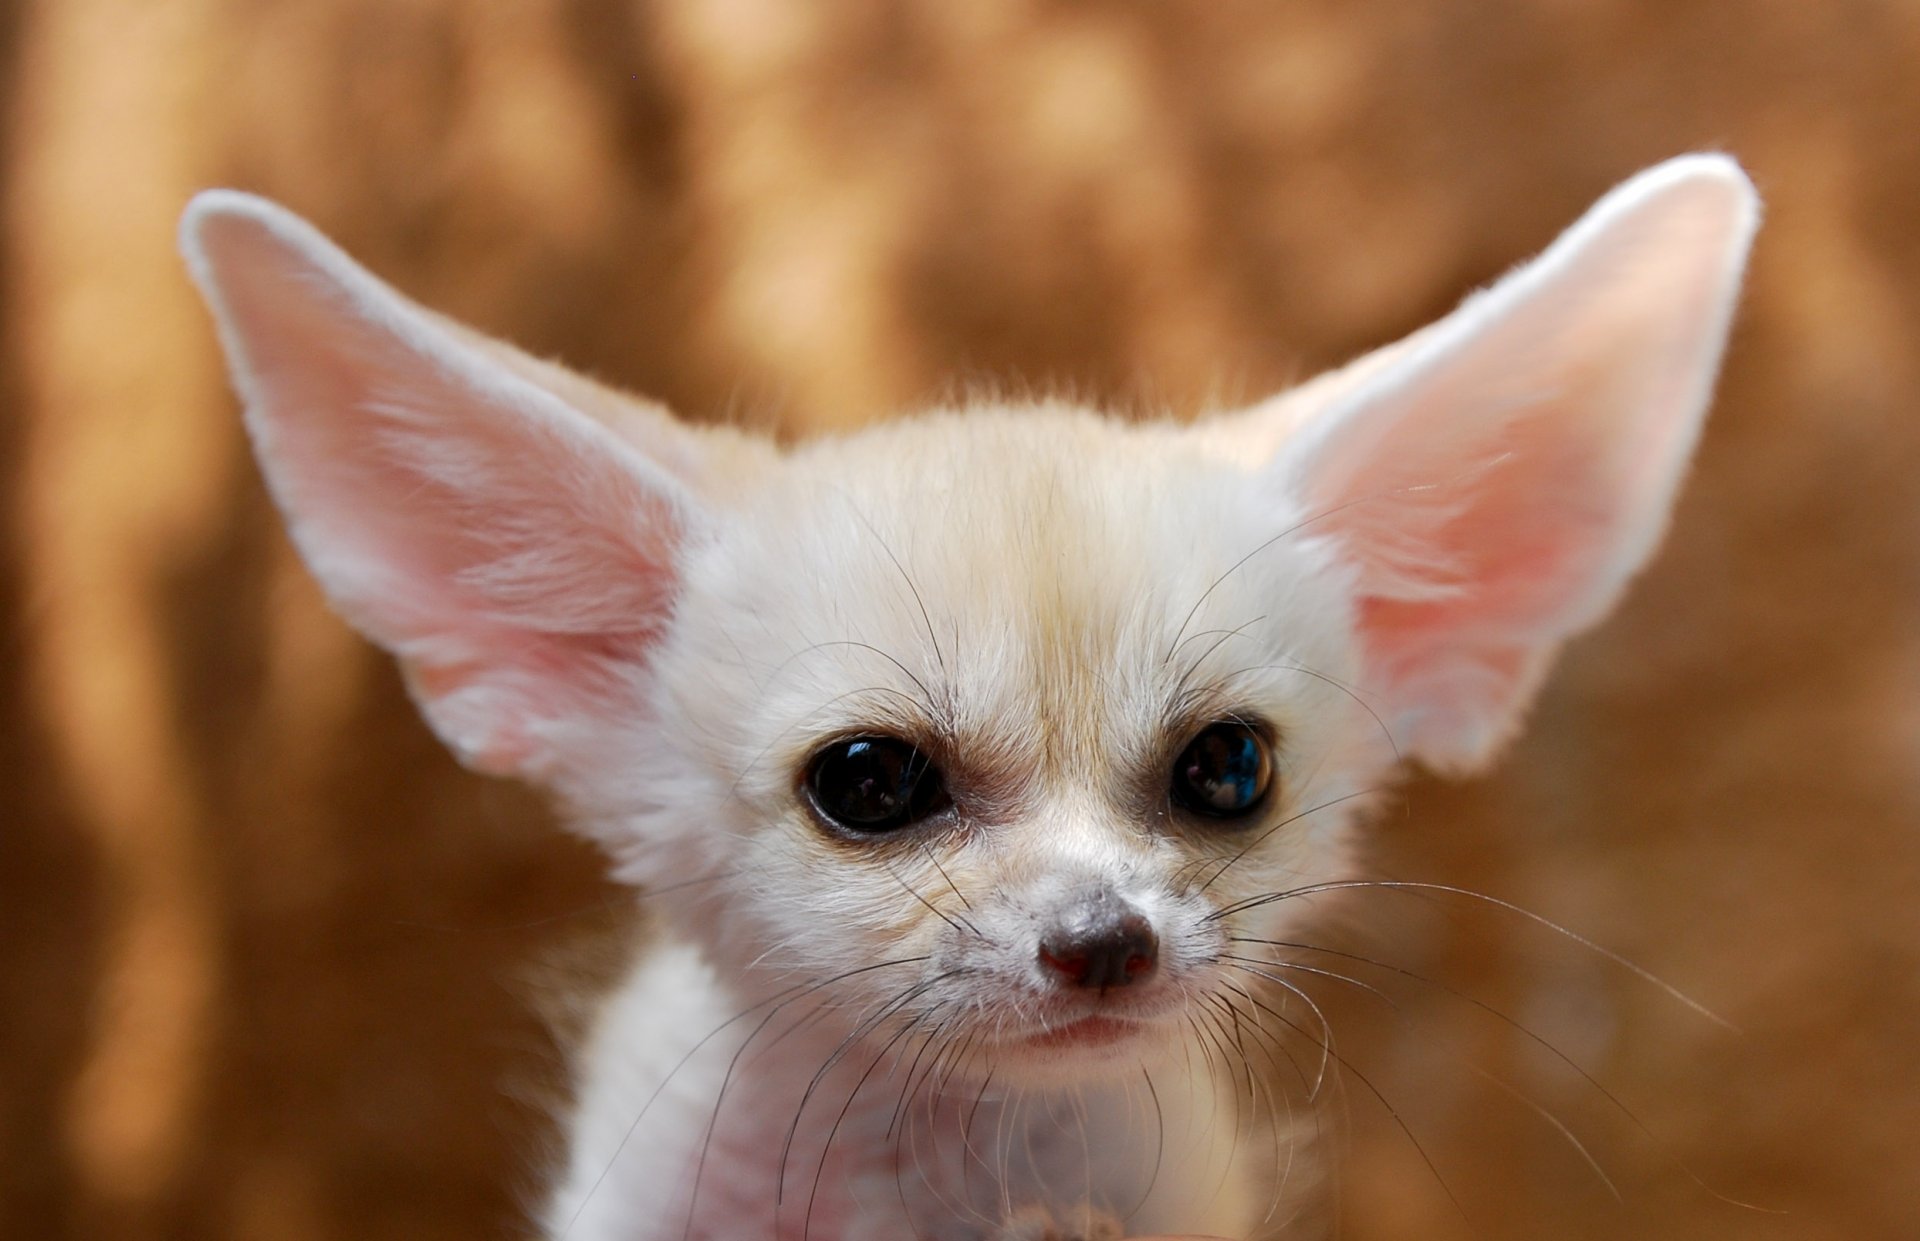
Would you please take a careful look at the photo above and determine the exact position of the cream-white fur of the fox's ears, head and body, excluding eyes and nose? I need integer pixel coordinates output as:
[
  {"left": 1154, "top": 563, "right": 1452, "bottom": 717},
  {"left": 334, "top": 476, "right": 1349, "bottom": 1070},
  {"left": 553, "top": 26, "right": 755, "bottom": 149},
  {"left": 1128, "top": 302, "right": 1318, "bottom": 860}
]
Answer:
[{"left": 182, "top": 156, "right": 1757, "bottom": 1241}]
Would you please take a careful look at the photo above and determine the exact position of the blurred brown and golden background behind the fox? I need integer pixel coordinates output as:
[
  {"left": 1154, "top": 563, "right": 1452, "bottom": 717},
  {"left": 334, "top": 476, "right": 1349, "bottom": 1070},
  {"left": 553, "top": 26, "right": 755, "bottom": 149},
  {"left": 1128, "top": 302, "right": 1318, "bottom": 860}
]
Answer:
[{"left": 0, "top": 0, "right": 1920, "bottom": 1241}]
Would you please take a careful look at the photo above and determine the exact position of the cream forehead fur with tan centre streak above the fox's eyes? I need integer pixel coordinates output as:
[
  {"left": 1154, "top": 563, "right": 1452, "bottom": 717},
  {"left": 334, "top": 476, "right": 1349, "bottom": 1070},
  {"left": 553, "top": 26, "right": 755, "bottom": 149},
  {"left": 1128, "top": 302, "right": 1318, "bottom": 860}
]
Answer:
[{"left": 662, "top": 405, "right": 1350, "bottom": 806}]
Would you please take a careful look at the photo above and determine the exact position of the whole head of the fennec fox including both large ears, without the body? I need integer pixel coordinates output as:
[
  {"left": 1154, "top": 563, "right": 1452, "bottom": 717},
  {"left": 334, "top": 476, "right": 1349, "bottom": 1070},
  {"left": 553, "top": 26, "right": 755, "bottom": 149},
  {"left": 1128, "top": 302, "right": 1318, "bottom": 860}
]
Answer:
[{"left": 182, "top": 156, "right": 1757, "bottom": 1080}]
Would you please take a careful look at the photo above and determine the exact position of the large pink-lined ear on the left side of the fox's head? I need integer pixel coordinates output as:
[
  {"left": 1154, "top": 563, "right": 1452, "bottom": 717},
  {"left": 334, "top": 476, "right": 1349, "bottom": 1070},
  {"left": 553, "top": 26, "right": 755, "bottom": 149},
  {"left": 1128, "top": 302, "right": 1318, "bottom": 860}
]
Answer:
[{"left": 180, "top": 190, "right": 703, "bottom": 780}]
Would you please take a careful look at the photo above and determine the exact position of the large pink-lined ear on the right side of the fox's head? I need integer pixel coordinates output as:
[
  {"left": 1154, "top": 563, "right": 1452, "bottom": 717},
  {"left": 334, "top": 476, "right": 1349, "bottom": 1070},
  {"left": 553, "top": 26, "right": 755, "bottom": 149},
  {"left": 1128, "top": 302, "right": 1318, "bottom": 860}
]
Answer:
[{"left": 1271, "top": 156, "right": 1759, "bottom": 770}]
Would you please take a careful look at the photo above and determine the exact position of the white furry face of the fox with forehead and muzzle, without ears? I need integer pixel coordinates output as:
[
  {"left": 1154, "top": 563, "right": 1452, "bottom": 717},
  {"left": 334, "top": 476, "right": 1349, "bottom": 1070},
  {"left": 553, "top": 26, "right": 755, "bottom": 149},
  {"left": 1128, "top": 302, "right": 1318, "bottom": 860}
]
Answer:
[{"left": 629, "top": 407, "right": 1394, "bottom": 1076}]
